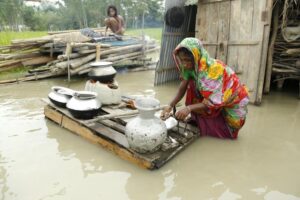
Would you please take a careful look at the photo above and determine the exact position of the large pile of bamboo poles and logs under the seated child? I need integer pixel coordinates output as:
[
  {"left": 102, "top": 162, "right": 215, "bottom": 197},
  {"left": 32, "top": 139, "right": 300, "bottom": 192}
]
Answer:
[{"left": 0, "top": 30, "right": 159, "bottom": 83}]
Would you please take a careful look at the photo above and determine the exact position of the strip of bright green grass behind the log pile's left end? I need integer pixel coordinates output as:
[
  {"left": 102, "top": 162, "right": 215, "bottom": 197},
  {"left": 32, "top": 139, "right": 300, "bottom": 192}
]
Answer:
[{"left": 0, "top": 31, "right": 47, "bottom": 46}]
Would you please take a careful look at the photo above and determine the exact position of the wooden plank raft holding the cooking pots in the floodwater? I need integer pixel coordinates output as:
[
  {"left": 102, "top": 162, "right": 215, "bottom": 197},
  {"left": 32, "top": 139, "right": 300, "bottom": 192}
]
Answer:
[{"left": 44, "top": 101, "right": 199, "bottom": 170}]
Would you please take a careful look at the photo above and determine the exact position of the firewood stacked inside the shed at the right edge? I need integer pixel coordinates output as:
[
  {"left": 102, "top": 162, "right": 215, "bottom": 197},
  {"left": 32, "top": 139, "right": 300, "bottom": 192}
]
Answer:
[{"left": 271, "top": 0, "right": 300, "bottom": 88}]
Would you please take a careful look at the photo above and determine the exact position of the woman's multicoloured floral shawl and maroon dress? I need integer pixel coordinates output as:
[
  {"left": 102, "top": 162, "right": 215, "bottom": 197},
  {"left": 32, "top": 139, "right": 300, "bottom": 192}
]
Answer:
[{"left": 173, "top": 38, "right": 249, "bottom": 138}]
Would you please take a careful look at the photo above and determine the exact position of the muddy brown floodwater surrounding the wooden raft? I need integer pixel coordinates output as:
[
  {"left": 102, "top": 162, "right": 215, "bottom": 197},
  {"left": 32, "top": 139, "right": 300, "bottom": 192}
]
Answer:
[{"left": 0, "top": 71, "right": 300, "bottom": 200}]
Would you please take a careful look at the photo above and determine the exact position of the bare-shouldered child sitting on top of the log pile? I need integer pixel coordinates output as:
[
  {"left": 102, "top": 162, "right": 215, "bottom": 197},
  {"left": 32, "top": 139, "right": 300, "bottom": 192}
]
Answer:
[{"left": 105, "top": 6, "right": 125, "bottom": 35}]
